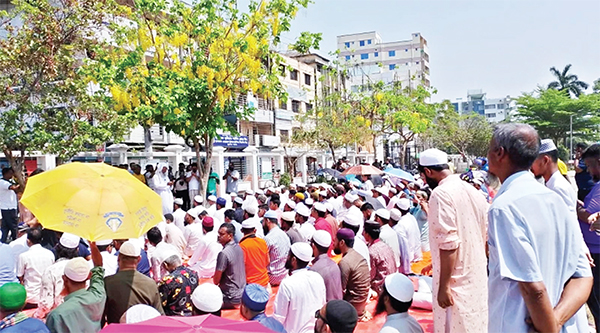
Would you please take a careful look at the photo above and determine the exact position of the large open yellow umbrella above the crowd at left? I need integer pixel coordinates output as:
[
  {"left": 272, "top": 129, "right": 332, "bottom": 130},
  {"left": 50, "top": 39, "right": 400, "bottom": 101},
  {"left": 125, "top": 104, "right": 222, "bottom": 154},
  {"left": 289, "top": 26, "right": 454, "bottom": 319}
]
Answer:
[{"left": 21, "top": 162, "right": 163, "bottom": 241}]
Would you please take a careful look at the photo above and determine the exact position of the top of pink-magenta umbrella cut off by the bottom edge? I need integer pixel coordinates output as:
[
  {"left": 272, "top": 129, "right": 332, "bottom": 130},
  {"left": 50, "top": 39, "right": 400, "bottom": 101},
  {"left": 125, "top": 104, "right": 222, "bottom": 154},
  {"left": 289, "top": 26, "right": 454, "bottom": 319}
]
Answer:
[{"left": 100, "top": 315, "right": 273, "bottom": 333}]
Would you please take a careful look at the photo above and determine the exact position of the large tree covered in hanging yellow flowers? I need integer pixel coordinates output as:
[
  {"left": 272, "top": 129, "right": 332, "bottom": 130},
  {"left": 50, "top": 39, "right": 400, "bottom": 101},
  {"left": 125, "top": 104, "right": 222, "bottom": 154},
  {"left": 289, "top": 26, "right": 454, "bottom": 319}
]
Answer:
[{"left": 90, "top": 0, "right": 310, "bottom": 195}]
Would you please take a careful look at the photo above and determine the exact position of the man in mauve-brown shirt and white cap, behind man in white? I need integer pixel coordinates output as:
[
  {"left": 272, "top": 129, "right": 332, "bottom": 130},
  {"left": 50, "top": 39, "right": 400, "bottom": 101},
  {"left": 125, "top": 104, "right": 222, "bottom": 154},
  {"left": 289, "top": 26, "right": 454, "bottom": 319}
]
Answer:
[{"left": 310, "top": 230, "right": 342, "bottom": 302}]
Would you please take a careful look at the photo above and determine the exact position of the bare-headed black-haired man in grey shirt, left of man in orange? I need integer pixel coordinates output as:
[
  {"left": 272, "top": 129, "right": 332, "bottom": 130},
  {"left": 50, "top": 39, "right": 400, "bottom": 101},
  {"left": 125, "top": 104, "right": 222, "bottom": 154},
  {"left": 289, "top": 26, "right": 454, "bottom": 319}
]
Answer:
[{"left": 213, "top": 223, "right": 246, "bottom": 309}]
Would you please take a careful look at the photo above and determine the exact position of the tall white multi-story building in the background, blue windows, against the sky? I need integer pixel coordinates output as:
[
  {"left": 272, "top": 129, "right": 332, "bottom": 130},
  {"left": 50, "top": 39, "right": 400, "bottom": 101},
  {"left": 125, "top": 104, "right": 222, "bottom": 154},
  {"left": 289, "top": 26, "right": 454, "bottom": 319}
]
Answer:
[{"left": 337, "top": 31, "right": 431, "bottom": 91}]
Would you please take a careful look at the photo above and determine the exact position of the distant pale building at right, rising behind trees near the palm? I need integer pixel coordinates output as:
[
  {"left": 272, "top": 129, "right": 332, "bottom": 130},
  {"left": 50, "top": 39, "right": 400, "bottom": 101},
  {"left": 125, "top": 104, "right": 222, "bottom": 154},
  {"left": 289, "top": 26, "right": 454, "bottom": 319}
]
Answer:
[{"left": 452, "top": 89, "right": 516, "bottom": 123}]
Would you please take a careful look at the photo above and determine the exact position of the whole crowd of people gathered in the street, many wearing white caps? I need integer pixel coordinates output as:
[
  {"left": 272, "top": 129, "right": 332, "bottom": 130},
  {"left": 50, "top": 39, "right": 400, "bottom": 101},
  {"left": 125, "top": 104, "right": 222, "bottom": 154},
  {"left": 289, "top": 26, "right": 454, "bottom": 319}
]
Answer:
[{"left": 0, "top": 124, "right": 600, "bottom": 333}]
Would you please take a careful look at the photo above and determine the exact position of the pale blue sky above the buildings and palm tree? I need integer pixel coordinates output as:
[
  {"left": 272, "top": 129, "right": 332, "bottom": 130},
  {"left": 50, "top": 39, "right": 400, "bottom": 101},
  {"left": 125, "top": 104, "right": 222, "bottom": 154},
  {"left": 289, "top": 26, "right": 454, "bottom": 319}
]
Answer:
[{"left": 276, "top": 0, "right": 600, "bottom": 101}]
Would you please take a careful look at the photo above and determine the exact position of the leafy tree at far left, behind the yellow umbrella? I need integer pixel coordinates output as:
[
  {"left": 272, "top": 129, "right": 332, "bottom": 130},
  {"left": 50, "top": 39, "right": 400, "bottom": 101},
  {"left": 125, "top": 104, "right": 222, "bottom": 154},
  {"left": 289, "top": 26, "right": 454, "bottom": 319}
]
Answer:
[{"left": 0, "top": 0, "right": 129, "bottom": 185}]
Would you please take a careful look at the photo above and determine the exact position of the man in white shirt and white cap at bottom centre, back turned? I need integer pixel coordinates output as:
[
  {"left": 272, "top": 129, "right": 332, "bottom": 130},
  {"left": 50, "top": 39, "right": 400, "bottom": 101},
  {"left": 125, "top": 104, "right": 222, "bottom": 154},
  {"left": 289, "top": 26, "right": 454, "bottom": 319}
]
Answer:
[{"left": 273, "top": 242, "right": 326, "bottom": 333}]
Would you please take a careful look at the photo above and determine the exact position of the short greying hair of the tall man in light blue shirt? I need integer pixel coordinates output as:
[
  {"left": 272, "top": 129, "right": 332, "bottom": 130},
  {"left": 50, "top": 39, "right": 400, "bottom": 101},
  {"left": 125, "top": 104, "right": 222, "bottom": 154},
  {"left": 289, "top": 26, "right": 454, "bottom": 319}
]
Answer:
[{"left": 493, "top": 123, "right": 540, "bottom": 170}]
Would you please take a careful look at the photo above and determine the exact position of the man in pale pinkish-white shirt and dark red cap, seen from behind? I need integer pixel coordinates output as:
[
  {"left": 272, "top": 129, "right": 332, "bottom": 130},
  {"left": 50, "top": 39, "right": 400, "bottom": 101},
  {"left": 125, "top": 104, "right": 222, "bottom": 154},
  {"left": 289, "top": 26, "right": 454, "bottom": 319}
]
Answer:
[{"left": 188, "top": 216, "right": 223, "bottom": 279}]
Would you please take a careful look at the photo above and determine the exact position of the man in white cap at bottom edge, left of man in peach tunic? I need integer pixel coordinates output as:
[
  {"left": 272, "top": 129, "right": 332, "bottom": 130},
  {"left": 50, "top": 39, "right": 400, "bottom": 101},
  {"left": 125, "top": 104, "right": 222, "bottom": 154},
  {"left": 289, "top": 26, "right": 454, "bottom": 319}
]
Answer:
[{"left": 375, "top": 273, "right": 424, "bottom": 333}]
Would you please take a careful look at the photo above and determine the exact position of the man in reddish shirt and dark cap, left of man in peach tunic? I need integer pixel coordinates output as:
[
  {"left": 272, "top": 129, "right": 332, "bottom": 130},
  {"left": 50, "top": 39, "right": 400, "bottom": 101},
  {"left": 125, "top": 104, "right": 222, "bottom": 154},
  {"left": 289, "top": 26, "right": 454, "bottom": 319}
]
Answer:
[{"left": 363, "top": 221, "right": 398, "bottom": 294}]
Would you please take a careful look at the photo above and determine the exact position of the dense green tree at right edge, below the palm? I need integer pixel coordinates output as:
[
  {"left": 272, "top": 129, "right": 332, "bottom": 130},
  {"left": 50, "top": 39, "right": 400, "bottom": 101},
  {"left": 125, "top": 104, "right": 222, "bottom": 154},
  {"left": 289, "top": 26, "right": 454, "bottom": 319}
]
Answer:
[{"left": 516, "top": 89, "right": 600, "bottom": 143}]
